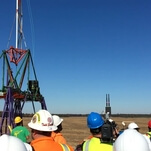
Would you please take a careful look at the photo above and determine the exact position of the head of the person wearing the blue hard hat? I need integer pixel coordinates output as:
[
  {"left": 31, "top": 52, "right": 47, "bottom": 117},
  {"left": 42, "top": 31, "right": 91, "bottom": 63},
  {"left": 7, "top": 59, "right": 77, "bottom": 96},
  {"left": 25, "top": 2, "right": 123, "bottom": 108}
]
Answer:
[{"left": 87, "top": 112, "right": 104, "bottom": 135}]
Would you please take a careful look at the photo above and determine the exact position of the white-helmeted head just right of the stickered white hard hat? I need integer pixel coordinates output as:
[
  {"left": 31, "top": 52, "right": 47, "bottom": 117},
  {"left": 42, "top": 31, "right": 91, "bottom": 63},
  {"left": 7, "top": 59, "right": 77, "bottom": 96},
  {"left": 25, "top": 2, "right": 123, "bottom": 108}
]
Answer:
[{"left": 52, "top": 115, "right": 63, "bottom": 132}]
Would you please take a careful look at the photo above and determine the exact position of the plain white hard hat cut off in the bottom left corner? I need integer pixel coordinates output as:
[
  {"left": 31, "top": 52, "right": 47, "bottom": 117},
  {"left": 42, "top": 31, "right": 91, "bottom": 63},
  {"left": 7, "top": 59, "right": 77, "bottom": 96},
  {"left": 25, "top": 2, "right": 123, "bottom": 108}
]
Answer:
[{"left": 0, "top": 134, "right": 27, "bottom": 151}]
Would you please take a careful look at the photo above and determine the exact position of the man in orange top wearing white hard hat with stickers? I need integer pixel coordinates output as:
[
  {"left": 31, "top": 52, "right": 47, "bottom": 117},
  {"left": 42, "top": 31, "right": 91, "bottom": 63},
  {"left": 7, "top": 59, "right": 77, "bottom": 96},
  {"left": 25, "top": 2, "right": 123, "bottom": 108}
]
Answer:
[{"left": 28, "top": 110, "right": 73, "bottom": 151}]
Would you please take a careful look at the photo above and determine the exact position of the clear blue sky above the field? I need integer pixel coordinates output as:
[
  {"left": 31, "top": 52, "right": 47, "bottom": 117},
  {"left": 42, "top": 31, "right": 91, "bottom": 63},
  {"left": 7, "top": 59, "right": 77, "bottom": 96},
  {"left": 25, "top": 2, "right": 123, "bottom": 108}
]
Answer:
[{"left": 0, "top": 0, "right": 151, "bottom": 114}]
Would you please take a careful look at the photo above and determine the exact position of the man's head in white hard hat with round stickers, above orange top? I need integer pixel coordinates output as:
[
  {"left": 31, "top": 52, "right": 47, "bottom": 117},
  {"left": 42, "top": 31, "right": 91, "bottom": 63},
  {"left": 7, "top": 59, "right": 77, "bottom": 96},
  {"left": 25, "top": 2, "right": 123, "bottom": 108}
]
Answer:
[{"left": 28, "top": 110, "right": 57, "bottom": 139}]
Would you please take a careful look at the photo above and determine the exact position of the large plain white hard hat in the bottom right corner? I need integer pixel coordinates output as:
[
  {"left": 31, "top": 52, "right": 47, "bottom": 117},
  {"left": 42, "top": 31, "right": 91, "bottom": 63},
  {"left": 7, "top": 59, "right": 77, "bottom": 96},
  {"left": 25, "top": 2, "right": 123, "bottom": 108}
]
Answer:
[{"left": 113, "top": 129, "right": 150, "bottom": 151}]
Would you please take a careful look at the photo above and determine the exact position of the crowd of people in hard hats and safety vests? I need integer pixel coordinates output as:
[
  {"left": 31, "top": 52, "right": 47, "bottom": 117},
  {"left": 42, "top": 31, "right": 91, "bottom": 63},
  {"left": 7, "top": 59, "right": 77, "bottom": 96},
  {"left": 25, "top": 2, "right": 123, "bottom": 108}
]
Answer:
[{"left": 0, "top": 110, "right": 151, "bottom": 151}]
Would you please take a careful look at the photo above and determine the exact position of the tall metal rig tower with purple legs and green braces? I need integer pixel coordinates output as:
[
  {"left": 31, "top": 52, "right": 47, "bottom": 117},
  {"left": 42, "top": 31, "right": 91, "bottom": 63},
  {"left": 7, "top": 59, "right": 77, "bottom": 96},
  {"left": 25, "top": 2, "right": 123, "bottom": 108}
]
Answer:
[{"left": 0, "top": 0, "right": 47, "bottom": 135}]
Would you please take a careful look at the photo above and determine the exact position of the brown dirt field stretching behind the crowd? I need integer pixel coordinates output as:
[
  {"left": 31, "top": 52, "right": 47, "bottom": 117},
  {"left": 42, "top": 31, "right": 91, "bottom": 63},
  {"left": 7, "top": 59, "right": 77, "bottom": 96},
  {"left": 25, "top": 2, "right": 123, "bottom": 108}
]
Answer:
[{"left": 23, "top": 117, "right": 150, "bottom": 148}]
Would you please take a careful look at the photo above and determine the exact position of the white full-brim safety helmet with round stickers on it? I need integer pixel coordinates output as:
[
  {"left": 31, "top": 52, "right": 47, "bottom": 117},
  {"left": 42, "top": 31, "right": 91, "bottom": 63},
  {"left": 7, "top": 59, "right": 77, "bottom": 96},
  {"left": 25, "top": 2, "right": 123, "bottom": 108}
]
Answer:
[{"left": 28, "top": 110, "right": 57, "bottom": 131}]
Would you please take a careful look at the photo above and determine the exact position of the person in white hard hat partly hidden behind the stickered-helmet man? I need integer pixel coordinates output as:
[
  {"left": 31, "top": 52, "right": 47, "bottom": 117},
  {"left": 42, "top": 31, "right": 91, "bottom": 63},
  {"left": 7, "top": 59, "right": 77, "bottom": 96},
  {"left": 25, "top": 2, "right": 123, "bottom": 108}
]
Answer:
[{"left": 51, "top": 115, "right": 67, "bottom": 144}]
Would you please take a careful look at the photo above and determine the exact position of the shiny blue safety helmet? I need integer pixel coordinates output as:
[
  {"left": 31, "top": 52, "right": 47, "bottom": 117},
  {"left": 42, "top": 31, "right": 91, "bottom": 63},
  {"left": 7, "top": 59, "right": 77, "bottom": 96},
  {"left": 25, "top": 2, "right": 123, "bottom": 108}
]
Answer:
[{"left": 87, "top": 112, "right": 104, "bottom": 129}]
